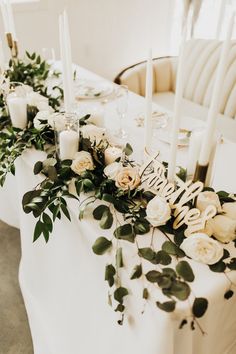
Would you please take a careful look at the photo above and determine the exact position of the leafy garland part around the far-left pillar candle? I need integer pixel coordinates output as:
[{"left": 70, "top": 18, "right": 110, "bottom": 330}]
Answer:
[{"left": 0, "top": 52, "right": 63, "bottom": 186}]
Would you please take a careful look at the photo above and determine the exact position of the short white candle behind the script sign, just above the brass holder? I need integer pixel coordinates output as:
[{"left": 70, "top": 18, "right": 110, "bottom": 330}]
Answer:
[{"left": 187, "top": 129, "right": 203, "bottom": 176}]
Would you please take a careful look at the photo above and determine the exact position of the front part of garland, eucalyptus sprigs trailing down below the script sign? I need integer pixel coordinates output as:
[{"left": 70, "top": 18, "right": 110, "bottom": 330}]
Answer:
[{"left": 23, "top": 116, "right": 236, "bottom": 333}]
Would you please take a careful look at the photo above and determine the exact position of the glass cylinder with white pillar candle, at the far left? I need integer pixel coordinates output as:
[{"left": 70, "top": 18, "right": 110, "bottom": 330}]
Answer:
[{"left": 5, "top": 82, "right": 28, "bottom": 129}]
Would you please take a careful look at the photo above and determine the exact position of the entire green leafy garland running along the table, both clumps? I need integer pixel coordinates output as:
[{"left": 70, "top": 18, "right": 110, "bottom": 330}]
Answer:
[{"left": 0, "top": 52, "right": 236, "bottom": 332}]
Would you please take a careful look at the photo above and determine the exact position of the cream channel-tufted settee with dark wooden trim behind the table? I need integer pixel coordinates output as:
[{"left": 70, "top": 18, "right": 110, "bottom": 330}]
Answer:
[{"left": 115, "top": 39, "right": 236, "bottom": 141}]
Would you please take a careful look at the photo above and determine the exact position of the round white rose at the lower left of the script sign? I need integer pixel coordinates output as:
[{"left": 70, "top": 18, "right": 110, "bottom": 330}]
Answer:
[{"left": 146, "top": 196, "right": 171, "bottom": 226}]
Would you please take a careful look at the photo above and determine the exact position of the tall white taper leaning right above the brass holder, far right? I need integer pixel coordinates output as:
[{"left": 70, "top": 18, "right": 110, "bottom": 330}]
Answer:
[{"left": 198, "top": 13, "right": 235, "bottom": 166}]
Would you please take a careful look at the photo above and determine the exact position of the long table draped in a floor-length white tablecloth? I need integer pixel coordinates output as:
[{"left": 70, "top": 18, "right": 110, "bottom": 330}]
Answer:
[{"left": 0, "top": 68, "right": 236, "bottom": 354}]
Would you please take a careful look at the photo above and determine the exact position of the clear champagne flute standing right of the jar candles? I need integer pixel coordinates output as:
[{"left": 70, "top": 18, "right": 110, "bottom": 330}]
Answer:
[{"left": 115, "top": 85, "right": 129, "bottom": 139}]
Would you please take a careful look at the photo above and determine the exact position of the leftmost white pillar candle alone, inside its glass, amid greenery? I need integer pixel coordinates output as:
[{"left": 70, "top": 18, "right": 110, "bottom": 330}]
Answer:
[{"left": 7, "top": 96, "right": 27, "bottom": 129}]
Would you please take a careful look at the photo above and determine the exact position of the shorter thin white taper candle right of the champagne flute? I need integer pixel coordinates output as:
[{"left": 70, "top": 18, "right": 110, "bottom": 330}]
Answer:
[{"left": 145, "top": 49, "right": 153, "bottom": 152}]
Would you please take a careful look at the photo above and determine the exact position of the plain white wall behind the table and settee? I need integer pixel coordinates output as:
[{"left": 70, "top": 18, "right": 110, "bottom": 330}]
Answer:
[{"left": 0, "top": 0, "right": 171, "bottom": 79}]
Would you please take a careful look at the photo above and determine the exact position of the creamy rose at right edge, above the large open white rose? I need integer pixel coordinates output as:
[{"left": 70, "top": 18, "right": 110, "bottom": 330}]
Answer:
[{"left": 207, "top": 215, "right": 236, "bottom": 243}]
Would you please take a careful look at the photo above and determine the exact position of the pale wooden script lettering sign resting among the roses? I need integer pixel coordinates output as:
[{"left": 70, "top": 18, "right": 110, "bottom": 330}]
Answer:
[{"left": 140, "top": 155, "right": 217, "bottom": 236}]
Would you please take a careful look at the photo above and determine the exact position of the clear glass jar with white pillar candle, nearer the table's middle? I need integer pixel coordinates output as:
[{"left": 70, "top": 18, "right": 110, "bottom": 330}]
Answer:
[{"left": 53, "top": 113, "right": 79, "bottom": 160}]
